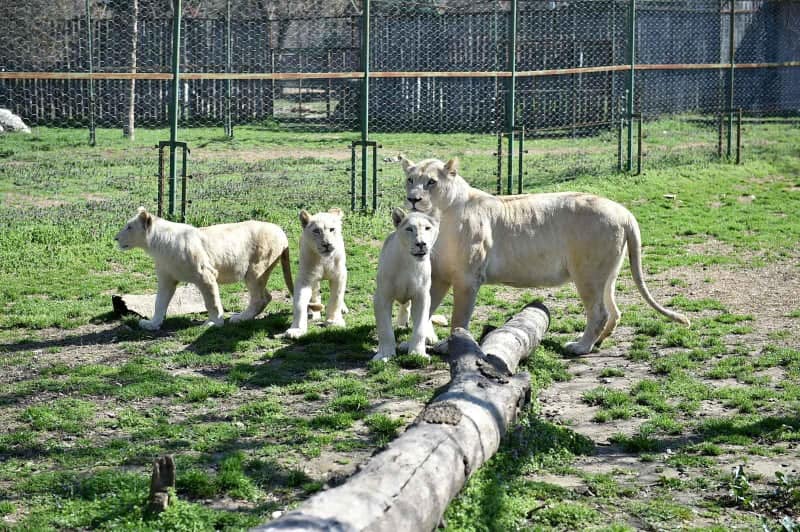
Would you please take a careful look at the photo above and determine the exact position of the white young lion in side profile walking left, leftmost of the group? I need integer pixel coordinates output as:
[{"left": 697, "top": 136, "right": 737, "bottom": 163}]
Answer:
[{"left": 114, "top": 207, "right": 293, "bottom": 331}]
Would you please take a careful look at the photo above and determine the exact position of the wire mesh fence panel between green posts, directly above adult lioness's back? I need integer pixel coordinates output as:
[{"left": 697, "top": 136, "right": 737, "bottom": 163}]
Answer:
[{"left": 516, "top": 0, "right": 627, "bottom": 186}]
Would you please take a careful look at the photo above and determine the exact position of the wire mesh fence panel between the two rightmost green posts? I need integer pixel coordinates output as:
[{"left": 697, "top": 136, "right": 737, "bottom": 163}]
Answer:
[{"left": 635, "top": 0, "right": 728, "bottom": 167}]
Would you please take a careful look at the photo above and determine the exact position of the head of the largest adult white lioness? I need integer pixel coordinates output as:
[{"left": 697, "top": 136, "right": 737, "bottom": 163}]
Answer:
[{"left": 400, "top": 155, "right": 458, "bottom": 213}]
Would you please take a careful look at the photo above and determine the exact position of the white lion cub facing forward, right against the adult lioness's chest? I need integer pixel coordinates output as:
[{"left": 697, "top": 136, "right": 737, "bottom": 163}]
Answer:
[{"left": 372, "top": 208, "right": 439, "bottom": 360}]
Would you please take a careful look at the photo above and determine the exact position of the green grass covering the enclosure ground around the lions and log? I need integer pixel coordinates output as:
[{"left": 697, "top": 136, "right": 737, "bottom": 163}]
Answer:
[{"left": 0, "top": 121, "right": 800, "bottom": 531}]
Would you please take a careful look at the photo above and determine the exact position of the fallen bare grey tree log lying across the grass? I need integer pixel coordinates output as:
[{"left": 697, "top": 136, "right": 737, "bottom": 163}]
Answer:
[{"left": 253, "top": 303, "right": 549, "bottom": 532}]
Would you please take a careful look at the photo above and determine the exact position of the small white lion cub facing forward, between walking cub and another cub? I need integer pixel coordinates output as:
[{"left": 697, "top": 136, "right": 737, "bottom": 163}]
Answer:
[{"left": 286, "top": 208, "right": 347, "bottom": 338}]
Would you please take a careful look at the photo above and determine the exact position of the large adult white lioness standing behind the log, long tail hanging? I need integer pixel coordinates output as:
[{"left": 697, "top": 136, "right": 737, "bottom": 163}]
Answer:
[{"left": 400, "top": 156, "right": 689, "bottom": 354}]
